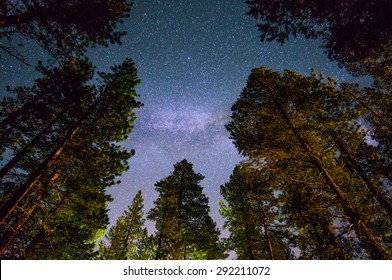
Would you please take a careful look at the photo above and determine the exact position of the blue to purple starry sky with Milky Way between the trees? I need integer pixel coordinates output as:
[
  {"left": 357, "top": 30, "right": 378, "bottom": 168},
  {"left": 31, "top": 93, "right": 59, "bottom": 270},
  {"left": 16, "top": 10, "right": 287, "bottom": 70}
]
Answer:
[{"left": 0, "top": 0, "right": 364, "bottom": 232}]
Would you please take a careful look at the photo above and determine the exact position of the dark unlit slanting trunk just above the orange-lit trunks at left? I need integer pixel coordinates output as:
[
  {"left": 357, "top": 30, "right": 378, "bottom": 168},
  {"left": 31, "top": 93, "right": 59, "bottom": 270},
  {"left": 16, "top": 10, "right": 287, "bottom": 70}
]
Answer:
[{"left": 0, "top": 106, "right": 67, "bottom": 180}]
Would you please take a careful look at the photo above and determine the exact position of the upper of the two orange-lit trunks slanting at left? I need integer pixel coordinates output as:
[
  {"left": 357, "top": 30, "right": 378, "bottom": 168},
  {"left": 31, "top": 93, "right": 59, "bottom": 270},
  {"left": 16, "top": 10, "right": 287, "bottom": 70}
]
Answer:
[{"left": 0, "top": 95, "right": 100, "bottom": 223}]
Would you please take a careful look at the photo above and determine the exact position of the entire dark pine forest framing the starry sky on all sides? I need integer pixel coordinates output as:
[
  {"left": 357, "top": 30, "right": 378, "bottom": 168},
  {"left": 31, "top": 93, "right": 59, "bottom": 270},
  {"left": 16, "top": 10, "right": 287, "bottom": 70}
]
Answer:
[{"left": 0, "top": 0, "right": 392, "bottom": 260}]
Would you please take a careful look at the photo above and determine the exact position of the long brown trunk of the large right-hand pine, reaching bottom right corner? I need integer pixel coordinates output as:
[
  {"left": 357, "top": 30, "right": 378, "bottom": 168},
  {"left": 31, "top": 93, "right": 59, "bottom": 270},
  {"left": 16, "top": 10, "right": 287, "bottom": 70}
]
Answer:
[{"left": 271, "top": 91, "right": 389, "bottom": 259}]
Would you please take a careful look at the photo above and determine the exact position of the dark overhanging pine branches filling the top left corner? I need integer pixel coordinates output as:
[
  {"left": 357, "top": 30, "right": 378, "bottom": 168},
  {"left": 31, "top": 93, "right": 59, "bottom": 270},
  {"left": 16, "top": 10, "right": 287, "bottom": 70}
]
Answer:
[{"left": 0, "top": 0, "right": 132, "bottom": 61}]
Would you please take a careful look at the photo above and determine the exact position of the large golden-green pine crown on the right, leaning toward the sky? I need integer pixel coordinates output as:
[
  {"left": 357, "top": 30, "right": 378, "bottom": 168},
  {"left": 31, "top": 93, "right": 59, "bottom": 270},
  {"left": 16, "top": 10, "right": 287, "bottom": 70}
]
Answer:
[{"left": 227, "top": 67, "right": 391, "bottom": 258}]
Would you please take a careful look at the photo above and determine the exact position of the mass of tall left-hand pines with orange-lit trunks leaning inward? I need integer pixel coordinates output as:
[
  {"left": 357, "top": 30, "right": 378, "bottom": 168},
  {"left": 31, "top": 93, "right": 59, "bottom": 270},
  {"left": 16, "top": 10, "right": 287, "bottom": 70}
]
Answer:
[{"left": 0, "top": 59, "right": 141, "bottom": 258}]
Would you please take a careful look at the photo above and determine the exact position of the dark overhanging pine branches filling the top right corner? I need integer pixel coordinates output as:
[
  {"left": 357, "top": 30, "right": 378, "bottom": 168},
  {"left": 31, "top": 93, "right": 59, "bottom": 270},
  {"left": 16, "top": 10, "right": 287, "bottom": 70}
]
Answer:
[{"left": 245, "top": 0, "right": 392, "bottom": 90}]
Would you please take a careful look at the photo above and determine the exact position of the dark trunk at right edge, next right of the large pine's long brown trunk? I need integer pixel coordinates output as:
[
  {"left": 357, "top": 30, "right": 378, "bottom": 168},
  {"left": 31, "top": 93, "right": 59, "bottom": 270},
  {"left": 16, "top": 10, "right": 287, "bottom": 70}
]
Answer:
[{"left": 332, "top": 134, "right": 392, "bottom": 218}]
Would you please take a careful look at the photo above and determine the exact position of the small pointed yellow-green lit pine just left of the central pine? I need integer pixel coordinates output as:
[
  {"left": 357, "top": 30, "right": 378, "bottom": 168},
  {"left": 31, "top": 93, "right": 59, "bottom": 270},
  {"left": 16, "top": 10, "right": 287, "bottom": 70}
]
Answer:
[{"left": 100, "top": 190, "right": 146, "bottom": 260}]
